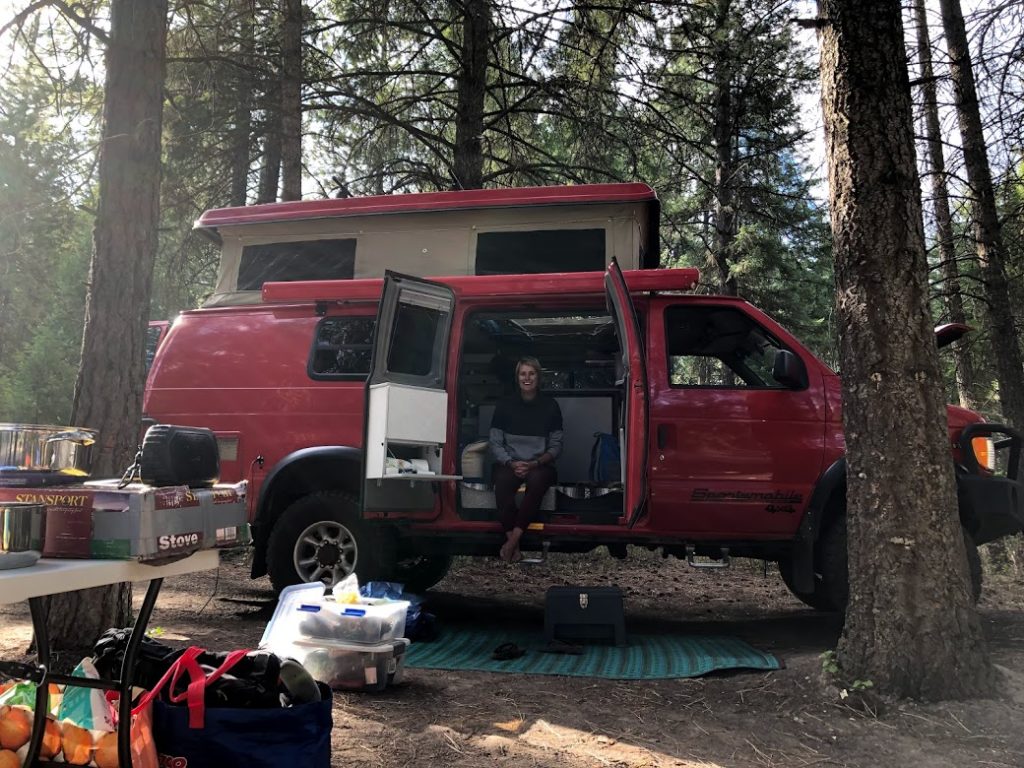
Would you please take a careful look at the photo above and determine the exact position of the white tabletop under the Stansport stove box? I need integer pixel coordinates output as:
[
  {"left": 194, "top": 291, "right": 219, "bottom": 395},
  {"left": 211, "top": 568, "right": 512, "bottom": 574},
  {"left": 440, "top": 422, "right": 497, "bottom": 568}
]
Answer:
[{"left": 0, "top": 549, "right": 220, "bottom": 603}]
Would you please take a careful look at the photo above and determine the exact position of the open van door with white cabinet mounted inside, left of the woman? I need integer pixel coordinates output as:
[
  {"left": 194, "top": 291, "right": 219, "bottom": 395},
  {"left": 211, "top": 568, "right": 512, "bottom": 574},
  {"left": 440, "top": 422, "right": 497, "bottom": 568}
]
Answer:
[{"left": 362, "top": 271, "right": 458, "bottom": 513}]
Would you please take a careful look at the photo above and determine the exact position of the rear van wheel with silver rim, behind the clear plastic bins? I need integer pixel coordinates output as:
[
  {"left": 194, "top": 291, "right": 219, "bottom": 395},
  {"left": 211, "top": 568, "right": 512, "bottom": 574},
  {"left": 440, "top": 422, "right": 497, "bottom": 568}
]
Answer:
[{"left": 266, "top": 490, "right": 395, "bottom": 592}]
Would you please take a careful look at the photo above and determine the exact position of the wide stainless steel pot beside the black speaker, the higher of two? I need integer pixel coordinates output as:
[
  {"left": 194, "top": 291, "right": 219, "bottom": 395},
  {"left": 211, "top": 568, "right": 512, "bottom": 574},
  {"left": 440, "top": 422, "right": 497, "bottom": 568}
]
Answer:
[{"left": 0, "top": 423, "right": 96, "bottom": 477}]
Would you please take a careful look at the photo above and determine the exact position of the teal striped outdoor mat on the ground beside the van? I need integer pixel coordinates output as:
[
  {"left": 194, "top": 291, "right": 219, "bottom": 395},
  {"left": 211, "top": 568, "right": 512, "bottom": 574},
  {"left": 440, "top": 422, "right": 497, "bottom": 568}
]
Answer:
[{"left": 406, "top": 627, "right": 782, "bottom": 680}]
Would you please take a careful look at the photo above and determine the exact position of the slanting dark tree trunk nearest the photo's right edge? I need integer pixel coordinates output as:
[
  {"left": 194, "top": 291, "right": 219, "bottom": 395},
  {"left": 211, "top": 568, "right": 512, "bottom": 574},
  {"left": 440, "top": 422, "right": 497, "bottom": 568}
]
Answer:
[{"left": 939, "top": 0, "right": 1024, "bottom": 429}]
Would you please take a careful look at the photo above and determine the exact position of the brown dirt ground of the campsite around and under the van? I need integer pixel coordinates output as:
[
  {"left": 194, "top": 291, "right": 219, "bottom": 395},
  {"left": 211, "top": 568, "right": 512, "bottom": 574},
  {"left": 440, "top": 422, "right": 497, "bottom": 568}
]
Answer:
[{"left": 0, "top": 554, "right": 1024, "bottom": 768}]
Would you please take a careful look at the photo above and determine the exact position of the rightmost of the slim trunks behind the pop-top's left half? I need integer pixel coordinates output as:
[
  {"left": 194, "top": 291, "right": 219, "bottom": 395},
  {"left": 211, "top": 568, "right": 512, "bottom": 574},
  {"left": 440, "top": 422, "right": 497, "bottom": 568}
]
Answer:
[{"left": 281, "top": 0, "right": 302, "bottom": 200}]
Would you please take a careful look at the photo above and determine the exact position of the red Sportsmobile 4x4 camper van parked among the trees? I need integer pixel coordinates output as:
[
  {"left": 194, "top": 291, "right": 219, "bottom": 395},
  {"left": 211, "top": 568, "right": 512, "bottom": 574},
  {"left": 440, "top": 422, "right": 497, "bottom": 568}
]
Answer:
[{"left": 144, "top": 187, "right": 1024, "bottom": 608}]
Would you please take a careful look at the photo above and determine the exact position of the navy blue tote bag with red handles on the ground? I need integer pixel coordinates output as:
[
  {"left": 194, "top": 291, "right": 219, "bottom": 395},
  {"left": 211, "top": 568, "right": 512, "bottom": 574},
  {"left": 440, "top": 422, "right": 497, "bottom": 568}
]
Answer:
[{"left": 140, "top": 648, "right": 333, "bottom": 768}]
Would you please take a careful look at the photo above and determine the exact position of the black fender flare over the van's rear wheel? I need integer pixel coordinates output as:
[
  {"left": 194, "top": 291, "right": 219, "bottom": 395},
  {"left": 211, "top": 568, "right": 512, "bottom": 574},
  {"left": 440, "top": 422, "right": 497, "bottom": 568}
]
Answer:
[{"left": 251, "top": 445, "right": 362, "bottom": 579}]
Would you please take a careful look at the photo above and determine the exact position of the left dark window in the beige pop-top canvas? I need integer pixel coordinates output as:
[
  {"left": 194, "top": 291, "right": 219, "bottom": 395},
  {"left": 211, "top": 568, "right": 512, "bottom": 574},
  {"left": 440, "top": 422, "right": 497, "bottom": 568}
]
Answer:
[{"left": 239, "top": 239, "right": 355, "bottom": 291}]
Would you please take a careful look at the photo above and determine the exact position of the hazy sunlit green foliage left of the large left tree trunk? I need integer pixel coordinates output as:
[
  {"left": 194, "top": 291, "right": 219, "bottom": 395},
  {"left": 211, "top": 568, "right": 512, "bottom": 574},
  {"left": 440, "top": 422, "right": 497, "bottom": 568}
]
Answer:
[{"left": 0, "top": 57, "right": 91, "bottom": 423}]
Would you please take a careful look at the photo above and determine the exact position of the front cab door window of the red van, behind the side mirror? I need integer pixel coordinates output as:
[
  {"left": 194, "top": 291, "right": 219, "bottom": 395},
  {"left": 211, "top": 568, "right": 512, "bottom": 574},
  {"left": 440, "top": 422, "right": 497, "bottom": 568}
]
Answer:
[{"left": 665, "top": 305, "right": 784, "bottom": 389}]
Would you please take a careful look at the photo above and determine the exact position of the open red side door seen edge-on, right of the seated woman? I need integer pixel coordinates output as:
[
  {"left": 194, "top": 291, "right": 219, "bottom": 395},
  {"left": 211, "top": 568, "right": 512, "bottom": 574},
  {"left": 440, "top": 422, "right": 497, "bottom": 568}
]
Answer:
[{"left": 604, "top": 258, "right": 647, "bottom": 527}]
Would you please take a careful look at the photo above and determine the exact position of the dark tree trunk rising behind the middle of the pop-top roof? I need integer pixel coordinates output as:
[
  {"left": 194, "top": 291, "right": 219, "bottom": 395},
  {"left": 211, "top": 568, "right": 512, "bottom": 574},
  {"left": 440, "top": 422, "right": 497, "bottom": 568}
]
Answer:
[{"left": 452, "top": 0, "right": 490, "bottom": 189}]
